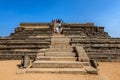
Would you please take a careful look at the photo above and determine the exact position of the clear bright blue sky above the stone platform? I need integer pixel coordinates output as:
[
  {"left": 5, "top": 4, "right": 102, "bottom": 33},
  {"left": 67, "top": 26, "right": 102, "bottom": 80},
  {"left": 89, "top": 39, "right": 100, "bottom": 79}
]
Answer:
[{"left": 0, "top": 0, "right": 120, "bottom": 37}]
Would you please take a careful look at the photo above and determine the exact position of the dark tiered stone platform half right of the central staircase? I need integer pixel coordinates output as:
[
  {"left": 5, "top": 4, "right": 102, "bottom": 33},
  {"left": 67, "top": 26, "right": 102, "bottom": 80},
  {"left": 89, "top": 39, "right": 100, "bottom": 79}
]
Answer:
[{"left": 63, "top": 23, "right": 120, "bottom": 61}]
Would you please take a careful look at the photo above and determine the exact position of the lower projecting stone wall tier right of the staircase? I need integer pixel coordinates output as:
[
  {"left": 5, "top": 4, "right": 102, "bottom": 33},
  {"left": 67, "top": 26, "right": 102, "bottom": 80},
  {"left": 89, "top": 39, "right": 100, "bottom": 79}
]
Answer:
[{"left": 71, "top": 38, "right": 120, "bottom": 61}]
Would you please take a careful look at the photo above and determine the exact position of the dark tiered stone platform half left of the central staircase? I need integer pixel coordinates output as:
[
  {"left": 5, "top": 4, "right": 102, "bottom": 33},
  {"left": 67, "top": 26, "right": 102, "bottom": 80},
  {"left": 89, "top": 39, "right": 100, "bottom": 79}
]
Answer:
[{"left": 0, "top": 23, "right": 52, "bottom": 59}]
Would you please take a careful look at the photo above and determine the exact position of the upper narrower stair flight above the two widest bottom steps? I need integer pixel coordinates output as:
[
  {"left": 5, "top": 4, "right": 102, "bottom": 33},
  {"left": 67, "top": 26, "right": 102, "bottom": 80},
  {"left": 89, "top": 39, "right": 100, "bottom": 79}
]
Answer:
[{"left": 37, "top": 35, "right": 77, "bottom": 61}]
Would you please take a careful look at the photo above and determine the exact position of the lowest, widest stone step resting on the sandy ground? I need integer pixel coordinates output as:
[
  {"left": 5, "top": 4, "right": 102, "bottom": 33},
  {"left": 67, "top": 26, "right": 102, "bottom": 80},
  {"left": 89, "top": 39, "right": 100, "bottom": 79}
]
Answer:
[{"left": 25, "top": 68, "right": 87, "bottom": 74}]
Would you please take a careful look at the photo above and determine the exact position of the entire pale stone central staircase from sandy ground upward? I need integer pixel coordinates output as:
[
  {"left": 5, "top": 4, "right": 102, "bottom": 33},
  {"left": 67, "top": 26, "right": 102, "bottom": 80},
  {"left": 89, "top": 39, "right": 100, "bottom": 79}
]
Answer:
[{"left": 26, "top": 34, "right": 96, "bottom": 74}]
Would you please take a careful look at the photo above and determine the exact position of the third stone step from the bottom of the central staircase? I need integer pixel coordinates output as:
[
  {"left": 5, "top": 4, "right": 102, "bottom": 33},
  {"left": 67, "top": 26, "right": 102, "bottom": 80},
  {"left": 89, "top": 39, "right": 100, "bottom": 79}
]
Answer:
[{"left": 36, "top": 56, "right": 77, "bottom": 61}]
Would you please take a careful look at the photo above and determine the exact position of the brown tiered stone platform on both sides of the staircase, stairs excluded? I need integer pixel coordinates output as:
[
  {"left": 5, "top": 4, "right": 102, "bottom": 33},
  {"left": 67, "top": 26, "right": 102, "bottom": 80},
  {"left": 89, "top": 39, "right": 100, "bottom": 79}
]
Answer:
[{"left": 0, "top": 23, "right": 120, "bottom": 61}]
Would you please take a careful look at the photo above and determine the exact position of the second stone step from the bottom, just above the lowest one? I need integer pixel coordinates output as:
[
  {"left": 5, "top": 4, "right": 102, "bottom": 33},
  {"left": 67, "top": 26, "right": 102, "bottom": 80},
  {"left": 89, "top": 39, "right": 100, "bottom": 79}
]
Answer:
[{"left": 32, "top": 60, "right": 90, "bottom": 68}]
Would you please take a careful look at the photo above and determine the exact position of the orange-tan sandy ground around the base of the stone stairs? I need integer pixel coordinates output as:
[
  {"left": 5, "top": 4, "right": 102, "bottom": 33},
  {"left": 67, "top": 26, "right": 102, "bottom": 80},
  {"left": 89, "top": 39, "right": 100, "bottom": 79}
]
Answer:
[{"left": 0, "top": 60, "right": 120, "bottom": 80}]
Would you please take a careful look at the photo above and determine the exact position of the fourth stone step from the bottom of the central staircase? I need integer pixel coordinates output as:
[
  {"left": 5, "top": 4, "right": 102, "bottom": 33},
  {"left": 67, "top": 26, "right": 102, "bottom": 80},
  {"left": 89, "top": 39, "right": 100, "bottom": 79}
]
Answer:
[{"left": 45, "top": 52, "right": 76, "bottom": 57}]
